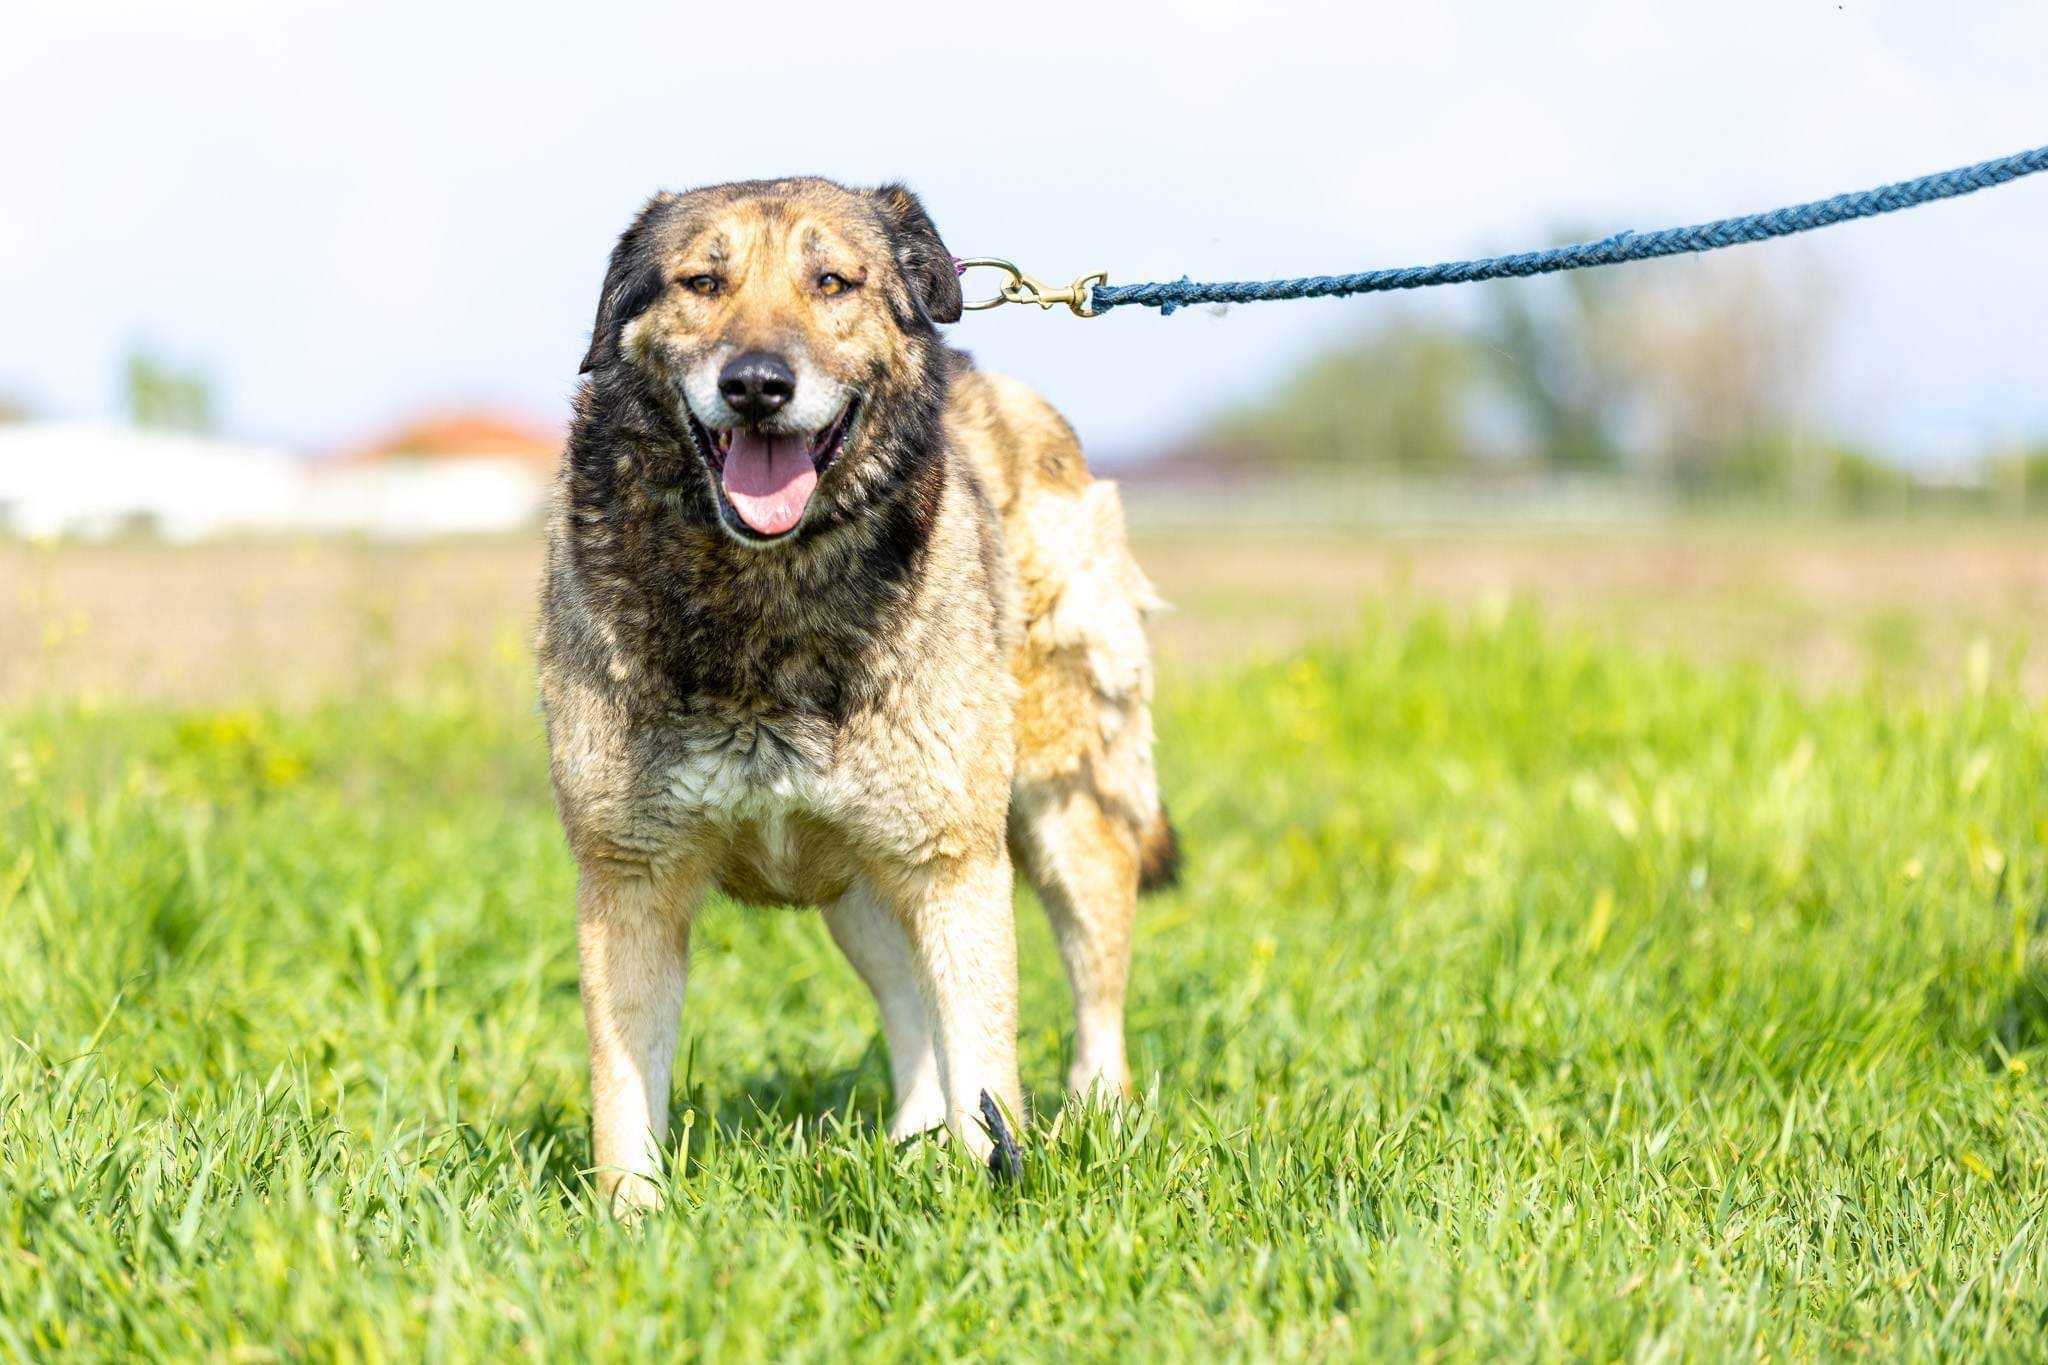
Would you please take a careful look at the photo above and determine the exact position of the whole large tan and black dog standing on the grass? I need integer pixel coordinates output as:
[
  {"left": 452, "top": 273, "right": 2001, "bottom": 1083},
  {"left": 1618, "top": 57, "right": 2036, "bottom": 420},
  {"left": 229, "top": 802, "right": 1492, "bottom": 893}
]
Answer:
[{"left": 539, "top": 178, "right": 1178, "bottom": 1209}]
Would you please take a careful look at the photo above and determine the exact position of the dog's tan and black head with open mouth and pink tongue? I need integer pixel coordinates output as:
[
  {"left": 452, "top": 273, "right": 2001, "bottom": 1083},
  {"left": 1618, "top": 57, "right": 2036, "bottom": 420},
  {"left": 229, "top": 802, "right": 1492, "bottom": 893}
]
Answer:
[{"left": 584, "top": 180, "right": 961, "bottom": 546}]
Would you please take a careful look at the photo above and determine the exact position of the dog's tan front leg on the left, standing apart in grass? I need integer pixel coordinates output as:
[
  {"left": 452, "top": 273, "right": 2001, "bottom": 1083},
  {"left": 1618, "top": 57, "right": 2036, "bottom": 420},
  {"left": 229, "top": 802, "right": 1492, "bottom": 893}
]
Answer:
[{"left": 575, "top": 864, "right": 696, "bottom": 1214}]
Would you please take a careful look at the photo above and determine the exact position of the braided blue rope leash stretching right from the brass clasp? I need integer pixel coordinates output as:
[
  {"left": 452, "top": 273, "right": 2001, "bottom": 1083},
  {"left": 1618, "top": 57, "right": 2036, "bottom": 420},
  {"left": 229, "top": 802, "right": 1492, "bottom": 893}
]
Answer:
[{"left": 1087, "top": 147, "right": 2048, "bottom": 313}]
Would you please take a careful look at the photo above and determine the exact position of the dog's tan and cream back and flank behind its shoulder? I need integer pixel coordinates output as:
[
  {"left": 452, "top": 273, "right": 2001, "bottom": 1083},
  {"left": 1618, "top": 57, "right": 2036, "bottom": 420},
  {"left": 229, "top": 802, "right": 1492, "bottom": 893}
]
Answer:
[{"left": 946, "top": 370, "right": 1180, "bottom": 890}]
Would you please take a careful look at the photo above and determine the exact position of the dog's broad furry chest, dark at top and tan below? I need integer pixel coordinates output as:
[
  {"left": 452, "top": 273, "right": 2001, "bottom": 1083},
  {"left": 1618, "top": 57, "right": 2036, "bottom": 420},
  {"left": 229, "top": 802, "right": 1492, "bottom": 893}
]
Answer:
[{"left": 543, "top": 437, "right": 1010, "bottom": 902}]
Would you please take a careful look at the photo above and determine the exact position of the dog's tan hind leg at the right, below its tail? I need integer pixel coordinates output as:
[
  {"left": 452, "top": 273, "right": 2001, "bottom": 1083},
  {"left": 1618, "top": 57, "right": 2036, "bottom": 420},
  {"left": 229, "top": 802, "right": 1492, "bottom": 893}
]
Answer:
[{"left": 1012, "top": 782, "right": 1139, "bottom": 1097}]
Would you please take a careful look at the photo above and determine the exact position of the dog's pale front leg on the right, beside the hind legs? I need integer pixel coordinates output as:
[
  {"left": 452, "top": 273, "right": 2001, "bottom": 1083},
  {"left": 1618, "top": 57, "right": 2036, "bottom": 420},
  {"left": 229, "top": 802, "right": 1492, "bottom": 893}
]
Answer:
[{"left": 893, "top": 851, "right": 1024, "bottom": 1160}]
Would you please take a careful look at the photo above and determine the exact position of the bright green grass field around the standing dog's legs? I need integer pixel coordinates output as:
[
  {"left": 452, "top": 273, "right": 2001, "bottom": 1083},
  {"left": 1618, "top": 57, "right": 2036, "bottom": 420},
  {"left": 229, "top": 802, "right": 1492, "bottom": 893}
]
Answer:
[{"left": 0, "top": 614, "right": 2048, "bottom": 1361}]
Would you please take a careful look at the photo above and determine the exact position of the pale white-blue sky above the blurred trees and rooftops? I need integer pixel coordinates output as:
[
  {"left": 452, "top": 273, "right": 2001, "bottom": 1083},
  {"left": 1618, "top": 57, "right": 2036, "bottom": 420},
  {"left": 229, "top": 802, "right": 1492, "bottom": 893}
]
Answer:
[{"left": 0, "top": 0, "right": 2048, "bottom": 463}]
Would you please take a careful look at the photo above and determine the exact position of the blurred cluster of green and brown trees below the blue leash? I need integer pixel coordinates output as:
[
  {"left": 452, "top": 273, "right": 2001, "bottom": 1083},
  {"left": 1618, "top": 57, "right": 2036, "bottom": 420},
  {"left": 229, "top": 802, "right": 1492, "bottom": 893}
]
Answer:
[{"left": 1204, "top": 246, "right": 1859, "bottom": 505}]
